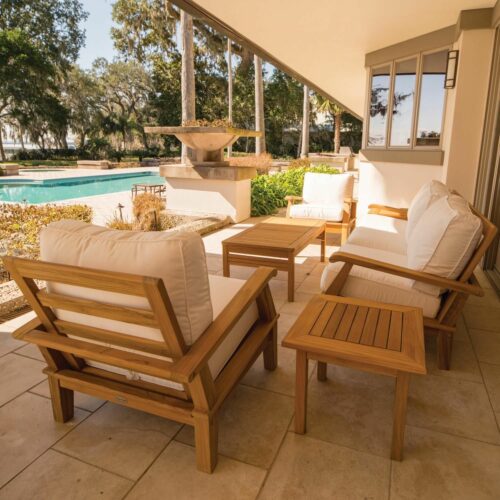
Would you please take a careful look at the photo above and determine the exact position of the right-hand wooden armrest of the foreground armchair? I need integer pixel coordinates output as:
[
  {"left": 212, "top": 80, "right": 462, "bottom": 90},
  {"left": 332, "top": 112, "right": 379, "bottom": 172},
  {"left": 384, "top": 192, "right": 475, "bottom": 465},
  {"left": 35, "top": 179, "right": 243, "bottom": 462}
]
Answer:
[{"left": 173, "top": 267, "right": 277, "bottom": 382}]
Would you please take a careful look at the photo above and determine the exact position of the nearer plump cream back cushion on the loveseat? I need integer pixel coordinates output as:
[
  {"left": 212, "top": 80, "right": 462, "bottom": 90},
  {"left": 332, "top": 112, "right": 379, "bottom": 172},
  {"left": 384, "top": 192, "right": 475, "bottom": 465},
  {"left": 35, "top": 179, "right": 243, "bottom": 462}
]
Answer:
[{"left": 408, "top": 194, "right": 482, "bottom": 290}]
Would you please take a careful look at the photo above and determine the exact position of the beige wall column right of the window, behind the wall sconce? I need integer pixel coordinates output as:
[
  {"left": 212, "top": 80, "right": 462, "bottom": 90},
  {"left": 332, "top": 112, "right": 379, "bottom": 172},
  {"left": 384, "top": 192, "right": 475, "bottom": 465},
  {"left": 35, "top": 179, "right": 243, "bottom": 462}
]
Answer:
[{"left": 442, "top": 29, "right": 495, "bottom": 202}]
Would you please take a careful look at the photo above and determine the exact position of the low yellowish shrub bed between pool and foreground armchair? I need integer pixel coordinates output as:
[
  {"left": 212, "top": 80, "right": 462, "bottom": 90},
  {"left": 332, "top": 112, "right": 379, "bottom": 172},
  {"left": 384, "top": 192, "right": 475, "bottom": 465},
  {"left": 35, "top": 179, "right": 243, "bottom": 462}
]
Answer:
[{"left": 0, "top": 203, "right": 92, "bottom": 280}]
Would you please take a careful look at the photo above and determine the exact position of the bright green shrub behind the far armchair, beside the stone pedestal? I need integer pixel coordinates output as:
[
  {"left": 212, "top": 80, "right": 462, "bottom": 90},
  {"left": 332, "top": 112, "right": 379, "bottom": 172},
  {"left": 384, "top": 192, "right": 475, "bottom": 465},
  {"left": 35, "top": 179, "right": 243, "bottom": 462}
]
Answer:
[{"left": 252, "top": 165, "right": 340, "bottom": 217}]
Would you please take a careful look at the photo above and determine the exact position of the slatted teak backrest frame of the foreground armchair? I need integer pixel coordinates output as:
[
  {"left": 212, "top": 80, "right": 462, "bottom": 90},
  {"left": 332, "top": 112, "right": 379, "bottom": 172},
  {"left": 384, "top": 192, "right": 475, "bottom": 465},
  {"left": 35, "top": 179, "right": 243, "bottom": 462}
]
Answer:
[{"left": 4, "top": 257, "right": 187, "bottom": 362}]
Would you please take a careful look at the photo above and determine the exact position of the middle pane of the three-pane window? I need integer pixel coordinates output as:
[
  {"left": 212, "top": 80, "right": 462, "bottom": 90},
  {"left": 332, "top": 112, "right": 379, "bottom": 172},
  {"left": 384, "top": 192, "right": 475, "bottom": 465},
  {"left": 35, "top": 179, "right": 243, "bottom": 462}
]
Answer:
[{"left": 391, "top": 59, "right": 417, "bottom": 146}]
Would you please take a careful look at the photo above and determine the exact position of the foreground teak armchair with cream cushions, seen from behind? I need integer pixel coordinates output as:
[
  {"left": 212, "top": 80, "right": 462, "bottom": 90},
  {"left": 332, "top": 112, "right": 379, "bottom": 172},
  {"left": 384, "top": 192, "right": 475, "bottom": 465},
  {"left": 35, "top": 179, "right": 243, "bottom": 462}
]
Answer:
[{"left": 4, "top": 221, "right": 278, "bottom": 472}]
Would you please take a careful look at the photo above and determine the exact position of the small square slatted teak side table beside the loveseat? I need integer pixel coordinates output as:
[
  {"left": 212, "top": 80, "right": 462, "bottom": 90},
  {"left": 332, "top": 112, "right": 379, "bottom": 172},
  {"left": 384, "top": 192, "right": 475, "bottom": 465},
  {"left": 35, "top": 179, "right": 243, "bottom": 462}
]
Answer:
[{"left": 283, "top": 295, "right": 426, "bottom": 460}]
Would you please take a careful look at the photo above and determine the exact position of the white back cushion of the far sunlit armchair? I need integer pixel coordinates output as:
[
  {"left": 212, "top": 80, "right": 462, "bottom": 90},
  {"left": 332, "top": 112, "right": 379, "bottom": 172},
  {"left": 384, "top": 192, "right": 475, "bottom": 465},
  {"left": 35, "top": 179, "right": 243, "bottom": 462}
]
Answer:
[{"left": 302, "top": 172, "right": 354, "bottom": 206}]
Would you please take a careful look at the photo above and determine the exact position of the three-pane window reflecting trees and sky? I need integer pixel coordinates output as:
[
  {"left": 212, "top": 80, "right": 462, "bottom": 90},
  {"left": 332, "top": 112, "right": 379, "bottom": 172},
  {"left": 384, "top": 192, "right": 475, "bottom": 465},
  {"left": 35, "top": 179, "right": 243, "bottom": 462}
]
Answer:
[{"left": 366, "top": 49, "right": 448, "bottom": 149}]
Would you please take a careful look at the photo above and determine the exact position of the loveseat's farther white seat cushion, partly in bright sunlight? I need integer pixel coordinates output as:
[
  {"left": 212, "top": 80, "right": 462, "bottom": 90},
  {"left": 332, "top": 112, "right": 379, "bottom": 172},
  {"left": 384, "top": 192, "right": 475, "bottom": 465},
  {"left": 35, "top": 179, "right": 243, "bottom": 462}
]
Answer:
[{"left": 347, "top": 214, "right": 407, "bottom": 255}]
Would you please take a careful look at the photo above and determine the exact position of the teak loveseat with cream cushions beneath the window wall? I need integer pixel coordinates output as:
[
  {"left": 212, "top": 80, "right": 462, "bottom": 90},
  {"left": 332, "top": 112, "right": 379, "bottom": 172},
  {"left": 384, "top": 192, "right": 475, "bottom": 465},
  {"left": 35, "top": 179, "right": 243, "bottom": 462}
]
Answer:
[{"left": 320, "top": 181, "right": 497, "bottom": 371}]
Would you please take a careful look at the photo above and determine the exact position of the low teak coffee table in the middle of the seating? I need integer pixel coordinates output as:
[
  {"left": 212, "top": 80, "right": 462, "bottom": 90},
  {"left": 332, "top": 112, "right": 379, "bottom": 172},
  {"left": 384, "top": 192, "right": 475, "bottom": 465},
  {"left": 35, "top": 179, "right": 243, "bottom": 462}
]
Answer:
[{"left": 222, "top": 217, "right": 326, "bottom": 302}]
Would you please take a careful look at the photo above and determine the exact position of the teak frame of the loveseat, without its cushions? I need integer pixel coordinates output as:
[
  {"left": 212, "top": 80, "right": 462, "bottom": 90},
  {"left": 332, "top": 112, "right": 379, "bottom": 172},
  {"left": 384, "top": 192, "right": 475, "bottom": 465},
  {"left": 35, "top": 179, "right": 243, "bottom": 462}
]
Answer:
[{"left": 326, "top": 201, "right": 497, "bottom": 370}]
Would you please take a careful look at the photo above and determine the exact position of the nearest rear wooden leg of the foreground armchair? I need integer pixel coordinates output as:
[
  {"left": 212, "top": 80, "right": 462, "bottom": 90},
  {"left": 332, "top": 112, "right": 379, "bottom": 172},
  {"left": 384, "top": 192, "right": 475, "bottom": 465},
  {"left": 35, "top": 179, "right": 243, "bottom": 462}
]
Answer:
[{"left": 193, "top": 411, "right": 218, "bottom": 474}]
